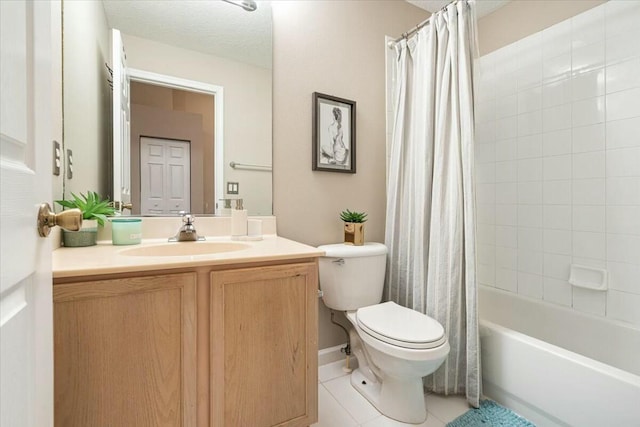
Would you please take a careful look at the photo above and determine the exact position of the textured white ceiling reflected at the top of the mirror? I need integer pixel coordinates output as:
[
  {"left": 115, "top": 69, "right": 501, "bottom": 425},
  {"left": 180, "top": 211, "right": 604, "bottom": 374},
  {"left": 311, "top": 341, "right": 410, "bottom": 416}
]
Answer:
[{"left": 102, "top": 0, "right": 272, "bottom": 69}]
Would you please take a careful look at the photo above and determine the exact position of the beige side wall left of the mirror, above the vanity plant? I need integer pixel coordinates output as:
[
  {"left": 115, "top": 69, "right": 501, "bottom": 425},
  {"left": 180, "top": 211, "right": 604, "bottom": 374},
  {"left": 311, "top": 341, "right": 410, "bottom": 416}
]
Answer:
[{"left": 62, "top": 1, "right": 111, "bottom": 201}]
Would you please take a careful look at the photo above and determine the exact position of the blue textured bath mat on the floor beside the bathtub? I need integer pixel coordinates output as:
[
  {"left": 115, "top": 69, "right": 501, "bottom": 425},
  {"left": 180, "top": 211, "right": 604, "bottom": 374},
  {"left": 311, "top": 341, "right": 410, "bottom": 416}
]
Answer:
[{"left": 447, "top": 400, "right": 536, "bottom": 427}]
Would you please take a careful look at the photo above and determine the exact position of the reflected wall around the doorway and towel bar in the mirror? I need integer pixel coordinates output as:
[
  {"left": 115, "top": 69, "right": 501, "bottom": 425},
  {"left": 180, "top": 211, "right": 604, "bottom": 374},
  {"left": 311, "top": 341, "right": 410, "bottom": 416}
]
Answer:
[{"left": 122, "top": 34, "right": 272, "bottom": 215}]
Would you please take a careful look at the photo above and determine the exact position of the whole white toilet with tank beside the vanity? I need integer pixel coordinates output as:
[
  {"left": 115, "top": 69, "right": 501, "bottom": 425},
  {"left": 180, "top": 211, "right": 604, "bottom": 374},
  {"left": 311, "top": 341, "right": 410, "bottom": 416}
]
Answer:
[{"left": 318, "top": 243, "right": 449, "bottom": 424}]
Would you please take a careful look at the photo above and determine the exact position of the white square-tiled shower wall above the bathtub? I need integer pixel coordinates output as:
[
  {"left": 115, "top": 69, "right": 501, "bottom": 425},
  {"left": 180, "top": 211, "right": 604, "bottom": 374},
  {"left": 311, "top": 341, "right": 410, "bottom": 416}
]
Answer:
[{"left": 476, "top": 0, "right": 640, "bottom": 326}]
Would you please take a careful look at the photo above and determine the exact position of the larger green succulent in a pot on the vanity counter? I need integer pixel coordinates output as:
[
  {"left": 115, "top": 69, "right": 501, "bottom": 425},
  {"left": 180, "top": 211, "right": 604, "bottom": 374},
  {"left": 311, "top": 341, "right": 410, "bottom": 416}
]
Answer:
[{"left": 56, "top": 191, "right": 115, "bottom": 247}]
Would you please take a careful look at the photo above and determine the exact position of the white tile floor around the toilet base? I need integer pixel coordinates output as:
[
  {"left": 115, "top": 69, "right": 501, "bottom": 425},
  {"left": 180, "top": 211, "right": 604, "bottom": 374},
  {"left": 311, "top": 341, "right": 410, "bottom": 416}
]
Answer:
[{"left": 312, "top": 361, "right": 469, "bottom": 427}]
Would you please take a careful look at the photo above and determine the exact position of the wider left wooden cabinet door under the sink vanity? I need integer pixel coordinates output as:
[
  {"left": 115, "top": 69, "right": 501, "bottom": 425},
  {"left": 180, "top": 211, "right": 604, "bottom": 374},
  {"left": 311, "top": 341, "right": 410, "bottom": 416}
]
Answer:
[{"left": 53, "top": 273, "right": 196, "bottom": 427}]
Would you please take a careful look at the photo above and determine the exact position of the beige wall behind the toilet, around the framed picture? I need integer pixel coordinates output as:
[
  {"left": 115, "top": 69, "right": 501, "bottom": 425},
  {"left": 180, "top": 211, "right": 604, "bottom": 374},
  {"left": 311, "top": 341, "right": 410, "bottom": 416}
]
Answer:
[{"left": 273, "top": 1, "right": 428, "bottom": 348}]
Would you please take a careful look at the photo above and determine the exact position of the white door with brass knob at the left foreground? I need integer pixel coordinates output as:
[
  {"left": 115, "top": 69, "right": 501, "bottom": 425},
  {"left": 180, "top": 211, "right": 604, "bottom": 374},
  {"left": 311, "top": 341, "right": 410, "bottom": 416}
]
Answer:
[{"left": 0, "top": 1, "right": 55, "bottom": 427}]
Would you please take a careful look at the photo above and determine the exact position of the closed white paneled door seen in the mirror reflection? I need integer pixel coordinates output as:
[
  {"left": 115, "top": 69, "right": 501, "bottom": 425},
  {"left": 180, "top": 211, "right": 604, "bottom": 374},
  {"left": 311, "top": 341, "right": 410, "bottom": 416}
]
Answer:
[{"left": 140, "top": 136, "right": 191, "bottom": 215}]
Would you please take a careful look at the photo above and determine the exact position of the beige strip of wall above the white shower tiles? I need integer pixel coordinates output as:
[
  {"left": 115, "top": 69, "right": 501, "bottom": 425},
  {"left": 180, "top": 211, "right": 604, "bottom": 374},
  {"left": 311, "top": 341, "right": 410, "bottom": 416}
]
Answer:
[{"left": 478, "top": 0, "right": 605, "bottom": 55}]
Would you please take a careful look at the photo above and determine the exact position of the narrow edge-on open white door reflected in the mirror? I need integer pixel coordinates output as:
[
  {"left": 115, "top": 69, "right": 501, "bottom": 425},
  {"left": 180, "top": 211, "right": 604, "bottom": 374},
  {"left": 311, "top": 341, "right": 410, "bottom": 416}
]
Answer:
[{"left": 111, "top": 29, "right": 131, "bottom": 209}]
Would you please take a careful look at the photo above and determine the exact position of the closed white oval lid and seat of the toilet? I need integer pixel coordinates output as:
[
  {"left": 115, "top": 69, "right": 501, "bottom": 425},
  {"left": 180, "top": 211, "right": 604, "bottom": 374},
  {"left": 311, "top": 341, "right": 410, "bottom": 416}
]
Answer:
[{"left": 356, "top": 301, "right": 446, "bottom": 349}]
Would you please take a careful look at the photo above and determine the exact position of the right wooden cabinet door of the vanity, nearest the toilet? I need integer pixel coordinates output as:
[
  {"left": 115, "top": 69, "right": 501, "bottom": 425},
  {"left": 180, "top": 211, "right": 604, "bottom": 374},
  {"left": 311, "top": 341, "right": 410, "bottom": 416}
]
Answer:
[{"left": 211, "top": 263, "right": 318, "bottom": 427}]
